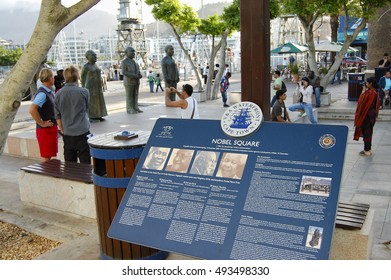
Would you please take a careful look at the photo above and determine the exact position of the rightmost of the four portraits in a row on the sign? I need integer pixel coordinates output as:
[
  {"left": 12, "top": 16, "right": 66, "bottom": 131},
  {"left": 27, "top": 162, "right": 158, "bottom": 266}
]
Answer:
[{"left": 216, "top": 153, "right": 247, "bottom": 179}]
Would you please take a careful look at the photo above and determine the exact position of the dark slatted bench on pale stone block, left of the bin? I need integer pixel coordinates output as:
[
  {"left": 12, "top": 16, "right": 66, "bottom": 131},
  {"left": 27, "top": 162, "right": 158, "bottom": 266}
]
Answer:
[{"left": 19, "top": 159, "right": 96, "bottom": 219}]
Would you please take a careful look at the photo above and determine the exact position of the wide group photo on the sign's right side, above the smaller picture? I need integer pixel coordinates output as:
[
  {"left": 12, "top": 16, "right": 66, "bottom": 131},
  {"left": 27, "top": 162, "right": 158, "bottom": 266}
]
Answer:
[{"left": 299, "top": 176, "right": 331, "bottom": 197}]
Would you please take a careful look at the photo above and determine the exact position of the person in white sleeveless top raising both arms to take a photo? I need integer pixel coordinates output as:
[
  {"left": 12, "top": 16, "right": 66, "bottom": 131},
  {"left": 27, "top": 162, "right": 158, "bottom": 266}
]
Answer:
[{"left": 165, "top": 84, "right": 200, "bottom": 119}]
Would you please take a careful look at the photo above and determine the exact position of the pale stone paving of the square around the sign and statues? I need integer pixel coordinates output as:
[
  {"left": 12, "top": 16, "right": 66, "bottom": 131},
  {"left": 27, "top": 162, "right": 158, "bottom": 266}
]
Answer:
[{"left": 0, "top": 75, "right": 391, "bottom": 260}]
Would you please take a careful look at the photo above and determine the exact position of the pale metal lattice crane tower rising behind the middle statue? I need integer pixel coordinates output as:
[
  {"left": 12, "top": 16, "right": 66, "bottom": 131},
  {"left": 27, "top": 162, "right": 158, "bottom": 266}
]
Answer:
[{"left": 117, "top": 0, "right": 148, "bottom": 66}]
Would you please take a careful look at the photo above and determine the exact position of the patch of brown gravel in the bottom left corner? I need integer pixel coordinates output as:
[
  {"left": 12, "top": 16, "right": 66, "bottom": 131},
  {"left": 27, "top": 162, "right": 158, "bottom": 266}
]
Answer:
[{"left": 0, "top": 221, "right": 61, "bottom": 260}]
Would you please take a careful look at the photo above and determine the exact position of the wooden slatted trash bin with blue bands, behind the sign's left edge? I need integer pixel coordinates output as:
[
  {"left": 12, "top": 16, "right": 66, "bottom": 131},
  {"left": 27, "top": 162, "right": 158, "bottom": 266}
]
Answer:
[{"left": 88, "top": 131, "right": 168, "bottom": 260}]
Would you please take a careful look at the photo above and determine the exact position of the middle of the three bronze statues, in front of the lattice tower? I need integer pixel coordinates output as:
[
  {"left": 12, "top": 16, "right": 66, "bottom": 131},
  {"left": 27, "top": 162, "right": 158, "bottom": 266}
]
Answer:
[{"left": 121, "top": 47, "right": 143, "bottom": 114}]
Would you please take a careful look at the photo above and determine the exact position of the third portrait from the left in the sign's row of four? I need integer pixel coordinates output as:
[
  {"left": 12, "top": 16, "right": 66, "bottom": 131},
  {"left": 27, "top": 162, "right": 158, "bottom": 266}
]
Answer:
[{"left": 190, "top": 151, "right": 220, "bottom": 176}]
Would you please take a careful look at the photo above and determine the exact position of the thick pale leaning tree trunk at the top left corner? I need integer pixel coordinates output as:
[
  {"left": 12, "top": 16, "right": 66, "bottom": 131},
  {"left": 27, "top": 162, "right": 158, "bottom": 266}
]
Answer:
[{"left": 0, "top": 0, "right": 100, "bottom": 154}]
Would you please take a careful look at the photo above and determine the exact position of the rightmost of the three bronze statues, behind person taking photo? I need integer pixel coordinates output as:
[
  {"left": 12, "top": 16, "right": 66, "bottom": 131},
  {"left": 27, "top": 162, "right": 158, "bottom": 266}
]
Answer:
[{"left": 162, "top": 45, "right": 179, "bottom": 101}]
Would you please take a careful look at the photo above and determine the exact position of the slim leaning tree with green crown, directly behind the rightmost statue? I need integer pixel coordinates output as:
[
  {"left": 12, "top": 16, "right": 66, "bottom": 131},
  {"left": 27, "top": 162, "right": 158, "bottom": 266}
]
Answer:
[{"left": 145, "top": 0, "right": 202, "bottom": 90}]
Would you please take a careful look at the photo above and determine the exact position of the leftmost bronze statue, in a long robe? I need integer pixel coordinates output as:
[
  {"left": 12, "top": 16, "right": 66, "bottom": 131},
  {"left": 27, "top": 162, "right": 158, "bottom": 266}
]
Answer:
[{"left": 81, "top": 50, "right": 107, "bottom": 122}]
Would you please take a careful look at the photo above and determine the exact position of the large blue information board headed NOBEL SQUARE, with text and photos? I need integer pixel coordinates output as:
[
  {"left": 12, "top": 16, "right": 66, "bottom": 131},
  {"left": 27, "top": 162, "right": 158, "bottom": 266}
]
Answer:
[{"left": 108, "top": 119, "right": 348, "bottom": 259}]
